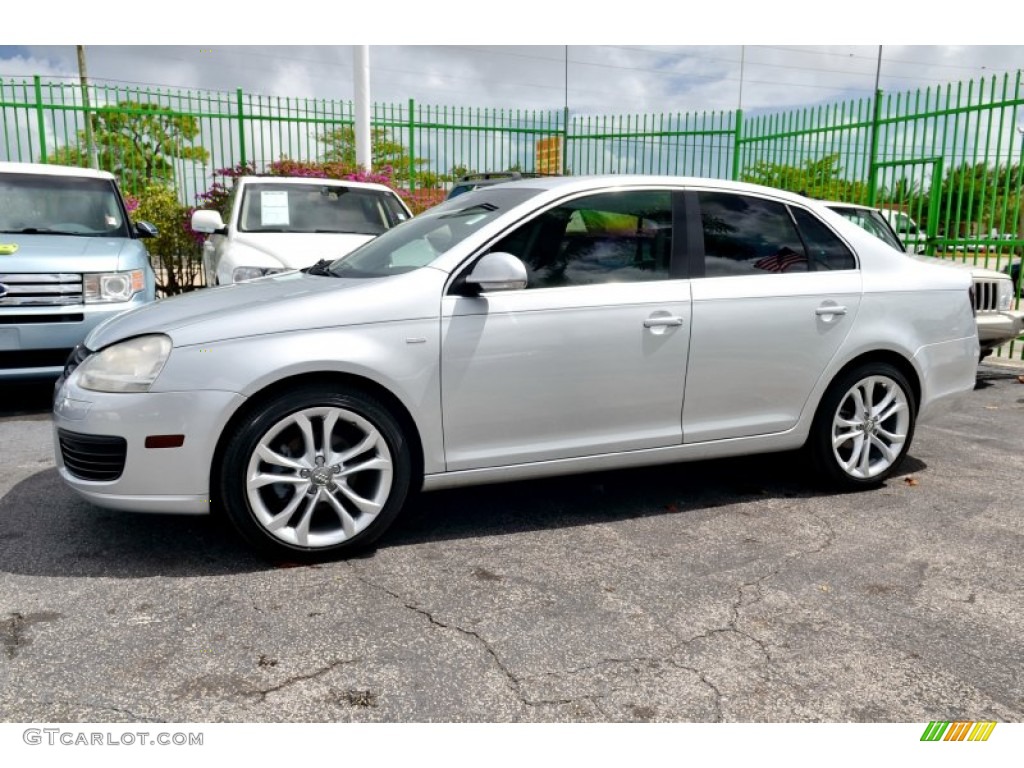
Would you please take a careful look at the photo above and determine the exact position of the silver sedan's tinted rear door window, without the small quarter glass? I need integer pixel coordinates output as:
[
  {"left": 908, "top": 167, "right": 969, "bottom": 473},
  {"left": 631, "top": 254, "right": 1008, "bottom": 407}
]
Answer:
[{"left": 698, "top": 193, "right": 808, "bottom": 278}]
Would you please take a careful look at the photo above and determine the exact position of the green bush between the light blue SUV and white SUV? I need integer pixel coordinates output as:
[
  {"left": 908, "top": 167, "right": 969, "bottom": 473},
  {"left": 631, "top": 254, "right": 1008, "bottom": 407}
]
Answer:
[{"left": 135, "top": 184, "right": 203, "bottom": 296}]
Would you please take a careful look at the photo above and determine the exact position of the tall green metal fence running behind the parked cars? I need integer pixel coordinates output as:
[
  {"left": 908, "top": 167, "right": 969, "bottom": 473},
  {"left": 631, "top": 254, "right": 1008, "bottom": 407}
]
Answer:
[{"left": 0, "top": 72, "right": 1024, "bottom": 357}]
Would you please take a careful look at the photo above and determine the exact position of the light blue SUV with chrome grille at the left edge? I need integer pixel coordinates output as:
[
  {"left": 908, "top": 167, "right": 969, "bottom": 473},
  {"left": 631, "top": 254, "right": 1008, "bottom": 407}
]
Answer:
[{"left": 0, "top": 163, "right": 157, "bottom": 381}]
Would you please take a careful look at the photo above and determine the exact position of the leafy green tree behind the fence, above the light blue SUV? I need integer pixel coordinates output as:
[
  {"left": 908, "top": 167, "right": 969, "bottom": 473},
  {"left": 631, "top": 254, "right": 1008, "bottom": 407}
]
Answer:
[{"left": 46, "top": 101, "right": 210, "bottom": 195}]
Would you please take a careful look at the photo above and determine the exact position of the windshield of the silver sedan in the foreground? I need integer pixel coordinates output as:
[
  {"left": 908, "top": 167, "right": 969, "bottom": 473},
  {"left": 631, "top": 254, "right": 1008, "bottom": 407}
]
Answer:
[{"left": 330, "top": 187, "right": 540, "bottom": 278}]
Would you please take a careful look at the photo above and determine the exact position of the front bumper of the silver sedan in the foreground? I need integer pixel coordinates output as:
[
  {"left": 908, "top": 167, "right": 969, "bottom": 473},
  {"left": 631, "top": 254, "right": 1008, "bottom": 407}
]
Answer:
[{"left": 53, "top": 375, "right": 245, "bottom": 514}]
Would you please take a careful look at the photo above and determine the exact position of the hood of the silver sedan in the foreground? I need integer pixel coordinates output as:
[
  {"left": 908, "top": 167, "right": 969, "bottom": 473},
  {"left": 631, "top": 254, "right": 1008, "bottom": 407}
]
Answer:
[{"left": 85, "top": 267, "right": 446, "bottom": 350}]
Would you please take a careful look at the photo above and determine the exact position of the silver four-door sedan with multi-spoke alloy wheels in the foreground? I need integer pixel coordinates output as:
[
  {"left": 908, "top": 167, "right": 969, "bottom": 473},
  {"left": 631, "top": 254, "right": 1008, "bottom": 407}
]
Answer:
[{"left": 54, "top": 176, "right": 978, "bottom": 560}]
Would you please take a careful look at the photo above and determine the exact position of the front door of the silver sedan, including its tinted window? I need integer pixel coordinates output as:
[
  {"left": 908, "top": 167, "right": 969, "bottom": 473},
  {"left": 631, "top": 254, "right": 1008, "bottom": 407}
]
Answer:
[{"left": 441, "top": 189, "right": 690, "bottom": 471}]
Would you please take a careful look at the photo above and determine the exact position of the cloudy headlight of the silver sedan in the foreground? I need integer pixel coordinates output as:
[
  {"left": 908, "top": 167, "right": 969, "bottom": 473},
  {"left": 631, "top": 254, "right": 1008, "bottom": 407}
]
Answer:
[{"left": 76, "top": 336, "right": 171, "bottom": 392}]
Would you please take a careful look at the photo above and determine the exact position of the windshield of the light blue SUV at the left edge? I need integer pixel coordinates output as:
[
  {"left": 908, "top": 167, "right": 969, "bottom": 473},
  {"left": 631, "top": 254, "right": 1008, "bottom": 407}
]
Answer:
[{"left": 0, "top": 173, "right": 129, "bottom": 238}]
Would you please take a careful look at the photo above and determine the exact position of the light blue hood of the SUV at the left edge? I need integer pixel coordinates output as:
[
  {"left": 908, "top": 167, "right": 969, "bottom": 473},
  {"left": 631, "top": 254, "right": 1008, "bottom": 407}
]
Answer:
[{"left": 0, "top": 233, "right": 132, "bottom": 274}]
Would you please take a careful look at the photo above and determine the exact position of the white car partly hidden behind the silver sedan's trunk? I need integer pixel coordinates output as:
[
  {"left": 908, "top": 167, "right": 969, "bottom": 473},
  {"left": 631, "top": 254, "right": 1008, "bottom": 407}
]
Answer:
[{"left": 825, "top": 201, "right": 1024, "bottom": 357}]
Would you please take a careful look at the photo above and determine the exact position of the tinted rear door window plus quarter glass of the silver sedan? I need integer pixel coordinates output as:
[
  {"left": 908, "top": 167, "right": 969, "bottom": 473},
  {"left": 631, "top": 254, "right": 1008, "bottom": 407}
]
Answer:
[{"left": 698, "top": 191, "right": 856, "bottom": 278}]
